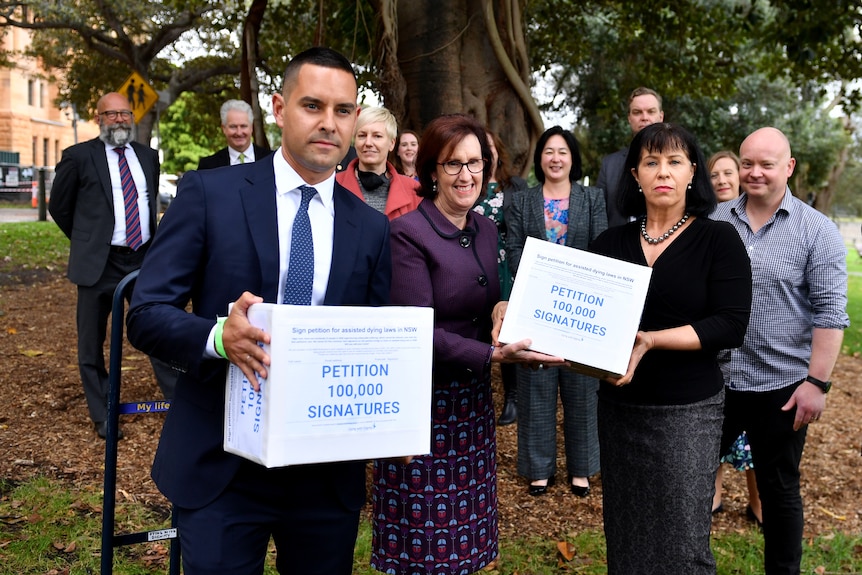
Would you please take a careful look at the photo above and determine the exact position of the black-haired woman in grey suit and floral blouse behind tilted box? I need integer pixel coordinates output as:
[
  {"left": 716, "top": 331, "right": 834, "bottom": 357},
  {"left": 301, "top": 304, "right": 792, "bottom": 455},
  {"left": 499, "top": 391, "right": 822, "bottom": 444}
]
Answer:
[{"left": 506, "top": 126, "right": 608, "bottom": 497}]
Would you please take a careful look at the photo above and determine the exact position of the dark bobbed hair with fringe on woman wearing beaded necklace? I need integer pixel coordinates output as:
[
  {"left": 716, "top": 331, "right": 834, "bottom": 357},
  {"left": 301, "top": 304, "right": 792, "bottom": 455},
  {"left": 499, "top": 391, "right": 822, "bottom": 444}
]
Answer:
[{"left": 619, "top": 122, "right": 717, "bottom": 217}]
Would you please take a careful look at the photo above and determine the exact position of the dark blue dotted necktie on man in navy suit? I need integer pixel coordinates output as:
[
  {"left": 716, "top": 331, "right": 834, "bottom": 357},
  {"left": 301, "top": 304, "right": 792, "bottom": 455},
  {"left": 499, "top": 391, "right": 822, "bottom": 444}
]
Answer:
[{"left": 282, "top": 186, "right": 317, "bottom": 305}]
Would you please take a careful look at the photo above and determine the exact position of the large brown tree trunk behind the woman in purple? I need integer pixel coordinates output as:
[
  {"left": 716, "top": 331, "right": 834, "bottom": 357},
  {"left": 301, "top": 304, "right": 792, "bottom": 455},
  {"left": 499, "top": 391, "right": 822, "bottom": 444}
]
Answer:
[{"left": 376, "top": 0, "right": 543, "bottom": 173}]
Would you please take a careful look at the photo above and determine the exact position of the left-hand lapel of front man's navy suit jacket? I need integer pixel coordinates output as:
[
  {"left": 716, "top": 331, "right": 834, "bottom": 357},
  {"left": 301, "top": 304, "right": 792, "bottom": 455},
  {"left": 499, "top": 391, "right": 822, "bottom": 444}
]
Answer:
[{"left": 237, "top": 162, "right": 279, "bottom": 303}]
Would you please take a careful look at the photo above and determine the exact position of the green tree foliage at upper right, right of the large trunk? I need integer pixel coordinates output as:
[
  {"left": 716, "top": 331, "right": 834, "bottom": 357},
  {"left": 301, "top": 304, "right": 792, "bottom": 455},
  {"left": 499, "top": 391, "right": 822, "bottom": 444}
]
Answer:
[{"left": 527, "top": 0, "right": 862, "bottom": 202}]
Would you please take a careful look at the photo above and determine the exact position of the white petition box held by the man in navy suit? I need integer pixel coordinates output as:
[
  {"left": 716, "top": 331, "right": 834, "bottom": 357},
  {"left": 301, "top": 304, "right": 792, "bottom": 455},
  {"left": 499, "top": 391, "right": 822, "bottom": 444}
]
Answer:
[{"left": 224, "top": 304, "right": 434, "bottom": 467}]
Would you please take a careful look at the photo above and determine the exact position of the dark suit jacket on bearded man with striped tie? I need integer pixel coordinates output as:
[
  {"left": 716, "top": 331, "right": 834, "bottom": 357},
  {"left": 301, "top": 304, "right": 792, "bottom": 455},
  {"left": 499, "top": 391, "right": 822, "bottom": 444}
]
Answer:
[{"left": 48, "top": 138, "right": 159, "bottom": 286}]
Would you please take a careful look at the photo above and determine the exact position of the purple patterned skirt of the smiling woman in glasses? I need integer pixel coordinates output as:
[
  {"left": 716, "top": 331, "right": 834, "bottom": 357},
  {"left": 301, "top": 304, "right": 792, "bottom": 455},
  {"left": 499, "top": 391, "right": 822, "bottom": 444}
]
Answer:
[{"left": 371, "top": 378, "right": 498, "bottom": 575}]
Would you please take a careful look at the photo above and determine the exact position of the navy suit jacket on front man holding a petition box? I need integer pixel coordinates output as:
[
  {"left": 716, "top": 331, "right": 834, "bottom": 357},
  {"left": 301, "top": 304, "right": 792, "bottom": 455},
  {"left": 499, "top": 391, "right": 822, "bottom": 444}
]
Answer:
[{"left": 127, "top": 159, "right": 392, "bottom": 509}]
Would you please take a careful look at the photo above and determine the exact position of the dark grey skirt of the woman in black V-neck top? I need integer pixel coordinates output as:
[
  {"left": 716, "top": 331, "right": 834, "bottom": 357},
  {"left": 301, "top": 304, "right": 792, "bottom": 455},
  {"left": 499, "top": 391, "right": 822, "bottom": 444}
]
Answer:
[{"left": 598, "top": 390, "right": 724, "bottom": 575}]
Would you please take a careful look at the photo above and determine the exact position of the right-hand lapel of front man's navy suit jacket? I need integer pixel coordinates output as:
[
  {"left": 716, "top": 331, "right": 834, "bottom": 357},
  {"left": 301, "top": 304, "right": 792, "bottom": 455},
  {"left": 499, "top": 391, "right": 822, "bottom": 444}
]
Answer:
[{"left": 323, "top": 187, "right": 360, "bottom": 305}]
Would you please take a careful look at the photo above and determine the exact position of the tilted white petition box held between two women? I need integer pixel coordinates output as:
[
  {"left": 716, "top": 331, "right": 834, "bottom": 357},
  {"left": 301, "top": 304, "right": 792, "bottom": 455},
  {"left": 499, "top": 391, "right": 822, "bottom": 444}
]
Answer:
[{"left": 500, "top": 238, "right": 652, "bottom": 378}]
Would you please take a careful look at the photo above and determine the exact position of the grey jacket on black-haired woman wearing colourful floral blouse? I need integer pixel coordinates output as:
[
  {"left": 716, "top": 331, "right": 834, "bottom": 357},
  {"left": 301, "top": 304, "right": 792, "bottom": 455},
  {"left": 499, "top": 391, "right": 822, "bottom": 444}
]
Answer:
[{"left": 505, "top": 182, "right": 608, "bottom": 274}]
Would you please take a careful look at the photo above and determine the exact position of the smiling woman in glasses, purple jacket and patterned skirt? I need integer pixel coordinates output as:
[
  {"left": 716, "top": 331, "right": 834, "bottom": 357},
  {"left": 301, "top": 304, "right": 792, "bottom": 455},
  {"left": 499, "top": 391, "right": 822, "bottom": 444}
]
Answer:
[{"left": 371, "top": 114, "right": 562, "bottom": 574}]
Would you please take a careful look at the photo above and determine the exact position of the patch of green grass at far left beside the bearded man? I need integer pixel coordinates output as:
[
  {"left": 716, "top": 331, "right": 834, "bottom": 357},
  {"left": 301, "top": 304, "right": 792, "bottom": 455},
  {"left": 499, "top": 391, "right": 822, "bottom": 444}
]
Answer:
[{"left": 0, "top": 222, "right": 69, "bottom": 273}]
